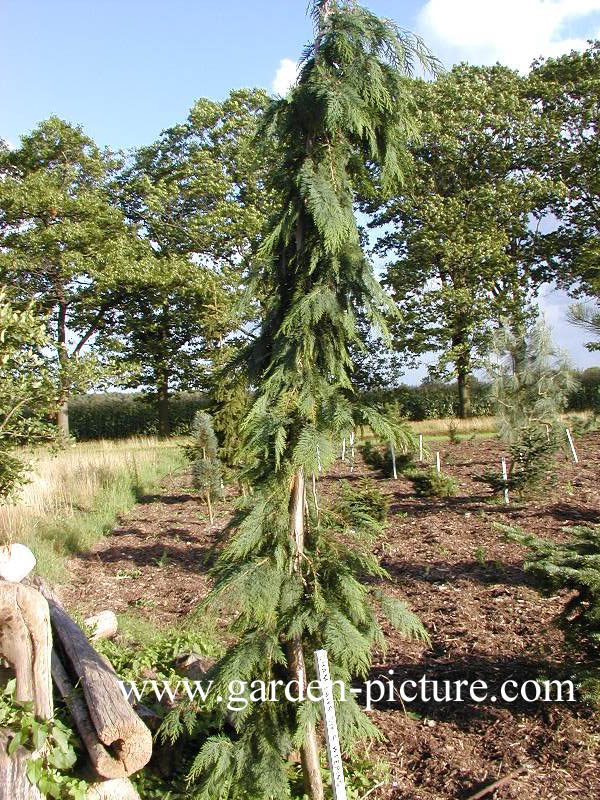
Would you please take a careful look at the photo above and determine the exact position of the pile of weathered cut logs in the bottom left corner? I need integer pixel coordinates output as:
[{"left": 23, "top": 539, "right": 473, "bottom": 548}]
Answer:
[{"left": 0, "top": 564, "right": 152, "bottom": 800}]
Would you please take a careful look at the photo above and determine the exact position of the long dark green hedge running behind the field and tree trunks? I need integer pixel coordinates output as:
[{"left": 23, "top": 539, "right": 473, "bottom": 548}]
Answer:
[{"left": 69, "top": 367, "right": 600, "bottom": 441}]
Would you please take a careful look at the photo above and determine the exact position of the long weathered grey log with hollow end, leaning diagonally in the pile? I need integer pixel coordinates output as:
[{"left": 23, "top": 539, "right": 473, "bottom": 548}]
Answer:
[{"left": 36, "top": 579, "right": 152, "bottom": 778}]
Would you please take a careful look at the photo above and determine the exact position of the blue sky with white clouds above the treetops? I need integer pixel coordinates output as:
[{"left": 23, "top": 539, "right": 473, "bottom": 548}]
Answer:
[{"left": 0, "top": 0, "right": 600, "bottom": 377}]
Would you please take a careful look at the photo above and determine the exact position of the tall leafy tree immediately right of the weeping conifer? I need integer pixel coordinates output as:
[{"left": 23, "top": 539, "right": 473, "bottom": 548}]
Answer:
[{"left": 370, "top": 65, "right": 553, "bottom": 417}]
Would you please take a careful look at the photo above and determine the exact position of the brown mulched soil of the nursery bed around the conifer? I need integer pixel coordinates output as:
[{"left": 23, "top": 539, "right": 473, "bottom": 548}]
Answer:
[{"left": 61, "top": 433, "right": 600, "bottom": 800}]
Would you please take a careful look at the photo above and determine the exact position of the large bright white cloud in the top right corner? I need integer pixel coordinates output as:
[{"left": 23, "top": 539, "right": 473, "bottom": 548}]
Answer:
[{"left": 419, "top": 0, "right": 600, "bottom": 71}]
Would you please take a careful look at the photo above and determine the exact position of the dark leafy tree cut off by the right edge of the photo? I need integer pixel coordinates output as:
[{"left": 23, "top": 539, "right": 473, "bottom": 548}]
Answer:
[{"left": 529, "top": 42, "right": 600, "bottom": 297}]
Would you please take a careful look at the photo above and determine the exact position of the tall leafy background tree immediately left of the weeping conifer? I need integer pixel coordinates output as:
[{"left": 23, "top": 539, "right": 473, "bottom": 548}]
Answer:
[{"left": 109, "top": 90, "right": 270, "bottom": 435}]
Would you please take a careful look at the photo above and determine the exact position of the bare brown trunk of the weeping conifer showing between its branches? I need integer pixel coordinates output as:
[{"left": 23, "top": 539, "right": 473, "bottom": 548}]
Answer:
[{"left": 286, "top": 469, "right": 324, "bottom": 800}]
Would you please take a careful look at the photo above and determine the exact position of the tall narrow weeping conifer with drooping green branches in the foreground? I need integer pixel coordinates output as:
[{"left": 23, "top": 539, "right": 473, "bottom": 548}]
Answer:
[{"left": 173, "top": 0, "right": 435, "bottom": 800}]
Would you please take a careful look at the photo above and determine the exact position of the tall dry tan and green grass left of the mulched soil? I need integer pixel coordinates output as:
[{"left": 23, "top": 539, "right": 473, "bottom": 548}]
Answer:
[{"left": 0, "top": 437, "right": 183, "bottom": 580}]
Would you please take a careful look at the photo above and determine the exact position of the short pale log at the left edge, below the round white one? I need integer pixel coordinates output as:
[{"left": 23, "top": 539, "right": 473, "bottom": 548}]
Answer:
[{"left": 0, "top": 581, "right": 53, "bottom": 719}]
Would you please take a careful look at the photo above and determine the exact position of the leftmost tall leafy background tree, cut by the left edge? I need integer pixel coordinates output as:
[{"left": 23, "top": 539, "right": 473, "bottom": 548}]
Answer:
[{"left": 0, "top": 117, "right": 135, "bottom": 435}]
